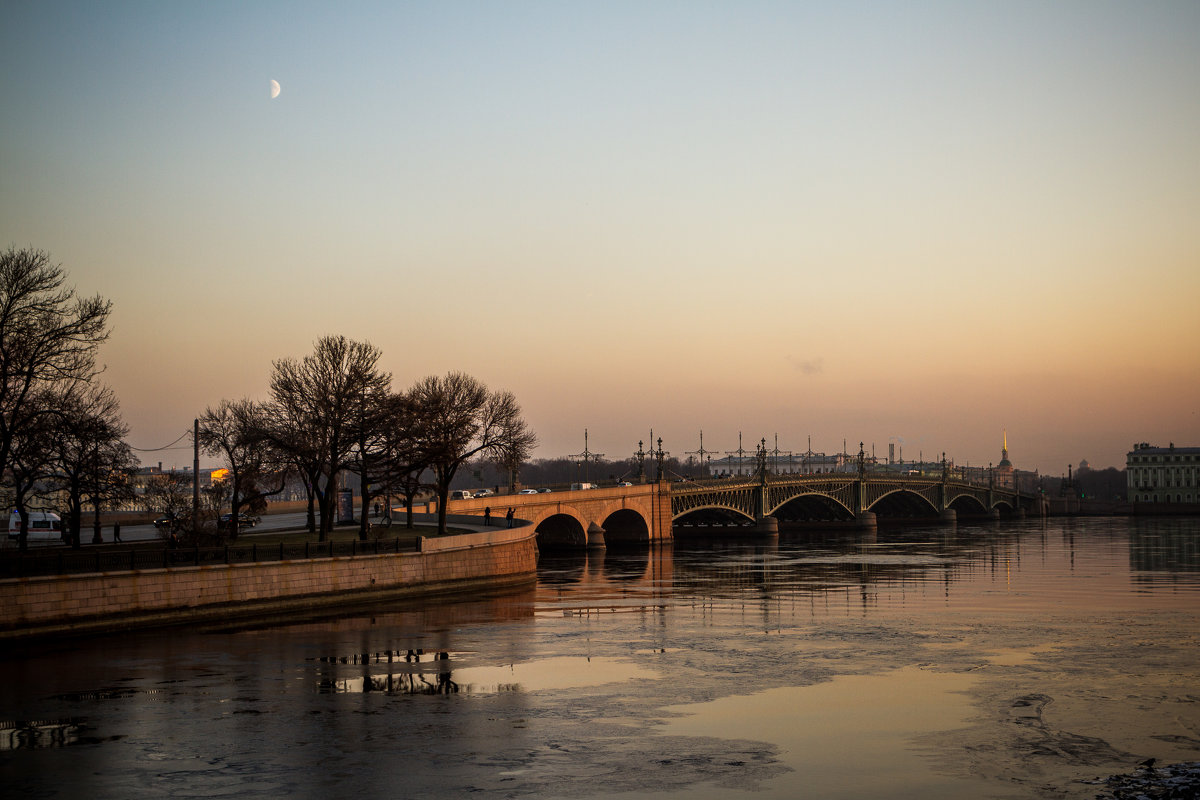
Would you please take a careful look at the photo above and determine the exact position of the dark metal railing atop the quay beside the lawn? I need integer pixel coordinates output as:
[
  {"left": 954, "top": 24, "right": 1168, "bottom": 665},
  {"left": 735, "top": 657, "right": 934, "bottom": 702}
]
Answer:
[{"left": 0, "top": 537, "right": 419, "bottom": 579}]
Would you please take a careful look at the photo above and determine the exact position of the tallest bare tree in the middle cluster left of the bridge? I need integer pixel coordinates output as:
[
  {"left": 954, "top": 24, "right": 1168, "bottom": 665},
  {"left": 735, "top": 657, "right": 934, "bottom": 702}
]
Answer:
[{"left": 270, "top": 336, "right": 391, "bottom": 541}]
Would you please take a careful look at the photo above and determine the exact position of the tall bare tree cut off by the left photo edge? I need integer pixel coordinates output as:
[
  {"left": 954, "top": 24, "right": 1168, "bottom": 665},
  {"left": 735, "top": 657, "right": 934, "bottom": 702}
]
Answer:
[{"left": 0, "top": 247, "right": 112, "bottom": 489}]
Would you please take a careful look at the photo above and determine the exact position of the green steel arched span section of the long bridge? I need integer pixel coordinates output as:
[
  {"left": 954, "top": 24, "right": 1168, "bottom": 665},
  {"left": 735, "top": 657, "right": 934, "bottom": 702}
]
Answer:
[{"left": 671, "top": 473, "right": 1039, "bottom": 522}]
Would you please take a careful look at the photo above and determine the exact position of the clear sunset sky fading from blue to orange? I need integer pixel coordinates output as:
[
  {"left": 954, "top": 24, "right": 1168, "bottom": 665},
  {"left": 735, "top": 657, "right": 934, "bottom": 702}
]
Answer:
[{"left": 0, "top": 0, "right": 1200, "bottom": 475}]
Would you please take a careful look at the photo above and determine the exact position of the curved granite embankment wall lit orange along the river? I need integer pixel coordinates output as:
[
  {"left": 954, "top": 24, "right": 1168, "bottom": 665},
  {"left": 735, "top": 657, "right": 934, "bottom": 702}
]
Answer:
[{"left": 0, "top": 525, "right": 538, "bottom": 639}]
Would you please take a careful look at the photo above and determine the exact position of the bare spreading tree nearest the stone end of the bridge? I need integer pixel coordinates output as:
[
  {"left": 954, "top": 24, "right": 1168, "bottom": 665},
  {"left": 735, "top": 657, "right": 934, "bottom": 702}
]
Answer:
[{"left": 410, "top": 372, "right": 538, "bottom": 533}]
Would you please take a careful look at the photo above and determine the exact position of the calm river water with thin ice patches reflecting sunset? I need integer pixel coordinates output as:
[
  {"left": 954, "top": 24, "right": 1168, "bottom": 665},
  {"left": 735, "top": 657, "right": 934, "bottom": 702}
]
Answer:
[{"left": 0, "top": 518, "right": 1200, "bottom": 800}]
